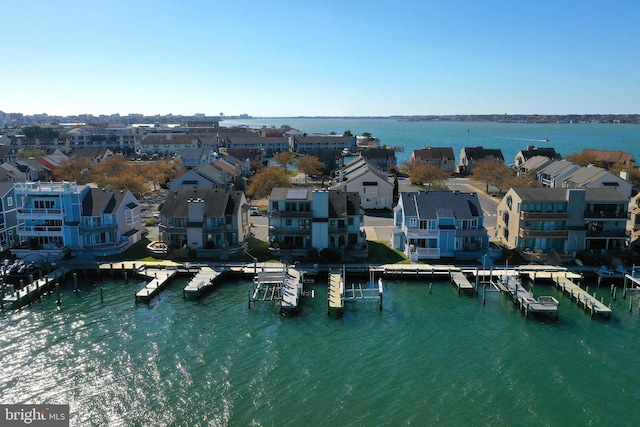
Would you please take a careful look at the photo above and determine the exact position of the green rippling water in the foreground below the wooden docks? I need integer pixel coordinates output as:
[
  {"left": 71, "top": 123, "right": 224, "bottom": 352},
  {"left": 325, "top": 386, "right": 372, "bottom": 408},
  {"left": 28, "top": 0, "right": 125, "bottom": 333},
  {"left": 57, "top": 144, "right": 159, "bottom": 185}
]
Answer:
[{"left": 0, "top": 277, "right": 640, "bottom": 426}]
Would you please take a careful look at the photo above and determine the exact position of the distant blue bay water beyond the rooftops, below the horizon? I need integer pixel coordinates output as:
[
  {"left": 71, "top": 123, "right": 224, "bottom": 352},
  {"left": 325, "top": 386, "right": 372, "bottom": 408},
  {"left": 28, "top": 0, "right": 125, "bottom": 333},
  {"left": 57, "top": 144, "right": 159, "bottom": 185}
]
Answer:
[{"left": 220, "top": 118, "right": 640, "bottom": 165}]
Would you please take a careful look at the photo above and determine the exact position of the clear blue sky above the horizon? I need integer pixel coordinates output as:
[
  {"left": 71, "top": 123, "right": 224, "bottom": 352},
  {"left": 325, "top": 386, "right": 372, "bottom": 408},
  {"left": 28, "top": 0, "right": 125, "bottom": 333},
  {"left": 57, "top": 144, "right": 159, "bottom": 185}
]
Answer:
[{"left": 5, "top": 0, "right": 640, "bottom": 116}]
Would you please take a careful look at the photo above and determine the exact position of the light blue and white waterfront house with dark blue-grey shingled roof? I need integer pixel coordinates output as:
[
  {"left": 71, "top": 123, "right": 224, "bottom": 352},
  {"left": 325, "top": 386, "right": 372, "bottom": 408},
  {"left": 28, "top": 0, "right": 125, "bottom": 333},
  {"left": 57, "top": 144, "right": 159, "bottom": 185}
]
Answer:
[{"left": 391, "top": 191, "right": 489, "bottom": 262}]
